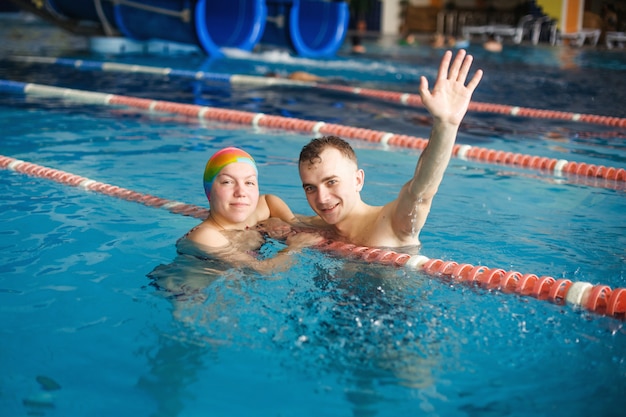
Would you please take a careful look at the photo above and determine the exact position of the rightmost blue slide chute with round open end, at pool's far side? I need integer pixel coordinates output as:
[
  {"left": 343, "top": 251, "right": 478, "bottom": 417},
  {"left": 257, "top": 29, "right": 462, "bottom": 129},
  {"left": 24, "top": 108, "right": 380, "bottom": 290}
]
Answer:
[{"left": 261, "top": 0, "right": 350, "bottom": 58}]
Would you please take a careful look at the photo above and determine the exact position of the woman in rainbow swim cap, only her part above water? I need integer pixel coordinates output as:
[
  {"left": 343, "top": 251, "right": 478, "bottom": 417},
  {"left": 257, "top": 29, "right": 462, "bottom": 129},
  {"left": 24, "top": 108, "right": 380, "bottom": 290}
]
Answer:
[{"left": 179, "top": 147, "right": 322, "bottom": 272}]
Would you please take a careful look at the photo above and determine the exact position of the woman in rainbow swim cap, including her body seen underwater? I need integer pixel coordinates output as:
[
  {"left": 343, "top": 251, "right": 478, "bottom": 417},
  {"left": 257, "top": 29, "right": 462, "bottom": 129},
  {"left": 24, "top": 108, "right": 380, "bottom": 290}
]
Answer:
[{"left": 148, "top": 147, "right": 322, "bottom": 314}]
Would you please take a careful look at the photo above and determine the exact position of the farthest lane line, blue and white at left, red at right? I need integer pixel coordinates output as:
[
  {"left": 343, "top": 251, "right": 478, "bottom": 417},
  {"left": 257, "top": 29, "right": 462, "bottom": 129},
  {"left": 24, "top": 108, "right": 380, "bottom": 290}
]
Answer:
[{"left": 9, "top": 56, "right": 626, "bottom": 127}]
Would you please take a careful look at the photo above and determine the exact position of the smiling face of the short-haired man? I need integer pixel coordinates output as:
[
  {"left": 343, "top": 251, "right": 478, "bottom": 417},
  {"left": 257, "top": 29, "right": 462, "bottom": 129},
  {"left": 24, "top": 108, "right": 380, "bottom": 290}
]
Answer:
[{"left": 300, "top": 148, "right": 364, "bottom": 225}]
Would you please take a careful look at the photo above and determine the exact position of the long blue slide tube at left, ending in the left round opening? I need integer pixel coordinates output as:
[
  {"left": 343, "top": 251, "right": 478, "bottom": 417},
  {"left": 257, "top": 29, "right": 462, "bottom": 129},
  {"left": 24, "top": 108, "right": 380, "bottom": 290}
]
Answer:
[{"left": 47, "top": 0, "right": 267, "bottom": 57}]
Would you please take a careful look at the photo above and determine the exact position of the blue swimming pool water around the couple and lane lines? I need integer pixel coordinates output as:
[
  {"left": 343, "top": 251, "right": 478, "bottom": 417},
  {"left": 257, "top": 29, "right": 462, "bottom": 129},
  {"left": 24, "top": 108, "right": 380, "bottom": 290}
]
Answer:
[{"left": 0, "top": 13, "right": 626, "bottom": 416}]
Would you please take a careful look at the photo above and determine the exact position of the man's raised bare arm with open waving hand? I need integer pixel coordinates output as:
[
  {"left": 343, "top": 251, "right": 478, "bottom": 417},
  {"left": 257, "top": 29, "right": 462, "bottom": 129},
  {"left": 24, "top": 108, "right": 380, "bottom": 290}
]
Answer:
[{"left": 392, "top": 50, "right": 483, "bottom": 238}]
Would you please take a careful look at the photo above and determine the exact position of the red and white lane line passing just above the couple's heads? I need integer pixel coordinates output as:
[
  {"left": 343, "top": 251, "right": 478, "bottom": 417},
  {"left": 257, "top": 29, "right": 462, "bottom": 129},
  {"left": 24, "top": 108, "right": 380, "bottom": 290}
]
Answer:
[{"left": 0, "top": 79, "right": 626, "bottom": 188}]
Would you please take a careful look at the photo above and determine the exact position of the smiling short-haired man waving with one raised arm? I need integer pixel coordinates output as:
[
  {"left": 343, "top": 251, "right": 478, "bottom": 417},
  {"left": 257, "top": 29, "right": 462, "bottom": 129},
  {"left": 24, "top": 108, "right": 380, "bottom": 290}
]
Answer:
[{"left": 299, "top": 50, "right": 482, "bottom": 247}]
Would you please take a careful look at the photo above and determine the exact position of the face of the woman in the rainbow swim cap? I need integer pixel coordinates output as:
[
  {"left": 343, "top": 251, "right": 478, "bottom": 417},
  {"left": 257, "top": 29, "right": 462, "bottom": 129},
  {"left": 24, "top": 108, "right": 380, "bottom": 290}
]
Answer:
[{"left": 210, "top": 162, "right": 259, "bottom": 223}]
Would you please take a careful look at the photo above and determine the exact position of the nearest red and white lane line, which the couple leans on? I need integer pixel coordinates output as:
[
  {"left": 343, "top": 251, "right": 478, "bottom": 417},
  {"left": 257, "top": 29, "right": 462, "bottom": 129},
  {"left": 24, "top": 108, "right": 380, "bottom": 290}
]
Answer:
[{"left": 0, "top": 155, "right": 626, "bottom": 320}]
